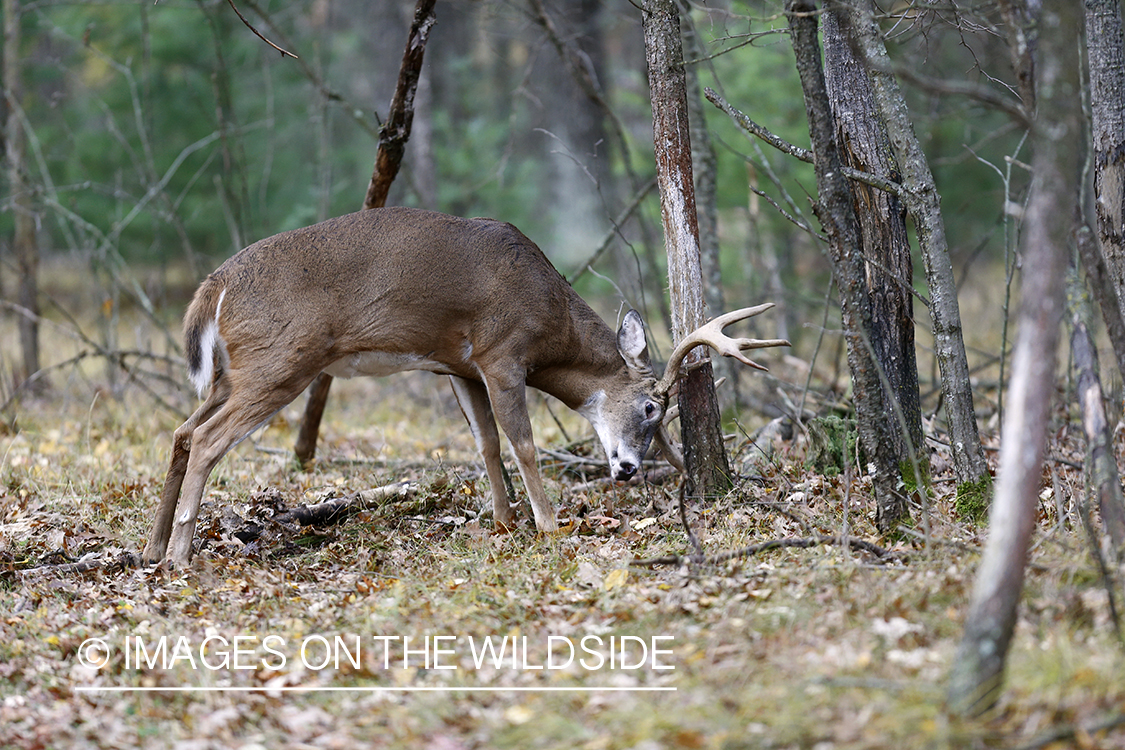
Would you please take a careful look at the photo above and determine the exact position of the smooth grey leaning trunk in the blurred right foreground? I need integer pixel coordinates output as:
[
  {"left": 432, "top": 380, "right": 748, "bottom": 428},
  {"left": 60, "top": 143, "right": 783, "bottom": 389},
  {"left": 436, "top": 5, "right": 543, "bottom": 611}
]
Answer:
[{"left": 948, "top": 0, "right": 1083, "bottom": 715}]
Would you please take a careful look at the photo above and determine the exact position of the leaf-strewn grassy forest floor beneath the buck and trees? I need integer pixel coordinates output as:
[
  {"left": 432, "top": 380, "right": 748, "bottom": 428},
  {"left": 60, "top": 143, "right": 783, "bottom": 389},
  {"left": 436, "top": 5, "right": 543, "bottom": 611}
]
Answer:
[{"left": 0, "top": 301, "right": 1125, "bottom": 750}]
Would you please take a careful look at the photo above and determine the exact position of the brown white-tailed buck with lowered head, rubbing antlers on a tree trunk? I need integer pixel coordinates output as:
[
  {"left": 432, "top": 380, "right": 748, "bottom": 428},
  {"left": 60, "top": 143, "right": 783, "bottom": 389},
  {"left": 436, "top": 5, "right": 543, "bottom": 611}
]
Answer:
[{"left": 142, "top": 208, "right": 788, "bottom": 566}]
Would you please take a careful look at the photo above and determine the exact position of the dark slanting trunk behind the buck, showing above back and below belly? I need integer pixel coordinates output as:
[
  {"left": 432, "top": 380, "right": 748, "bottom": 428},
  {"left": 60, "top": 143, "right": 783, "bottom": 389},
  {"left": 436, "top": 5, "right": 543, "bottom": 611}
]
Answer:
[{"left": 294, "top": 0, "right": 437, "bottom": 466}]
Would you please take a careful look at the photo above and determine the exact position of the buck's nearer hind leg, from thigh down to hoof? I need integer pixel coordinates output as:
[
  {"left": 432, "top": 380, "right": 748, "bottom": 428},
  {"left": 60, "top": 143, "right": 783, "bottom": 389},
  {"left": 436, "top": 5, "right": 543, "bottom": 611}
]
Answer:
[{"left": 160, "top": 377, "right": 312, "bottom": 568}]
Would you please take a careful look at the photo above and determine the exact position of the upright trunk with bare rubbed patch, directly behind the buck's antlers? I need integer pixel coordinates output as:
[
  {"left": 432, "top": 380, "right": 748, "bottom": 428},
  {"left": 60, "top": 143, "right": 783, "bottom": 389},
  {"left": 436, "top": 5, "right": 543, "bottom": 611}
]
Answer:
[{"left": 642, "top": 0, "right": 730, "bottom": 495}]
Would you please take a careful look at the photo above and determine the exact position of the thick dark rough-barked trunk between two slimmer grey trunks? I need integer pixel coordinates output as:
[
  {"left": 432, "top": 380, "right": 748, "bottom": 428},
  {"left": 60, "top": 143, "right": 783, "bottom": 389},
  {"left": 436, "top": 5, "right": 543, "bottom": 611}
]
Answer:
[{"left": 822, "top": 10, "right": 929, "bottom": 487}]
